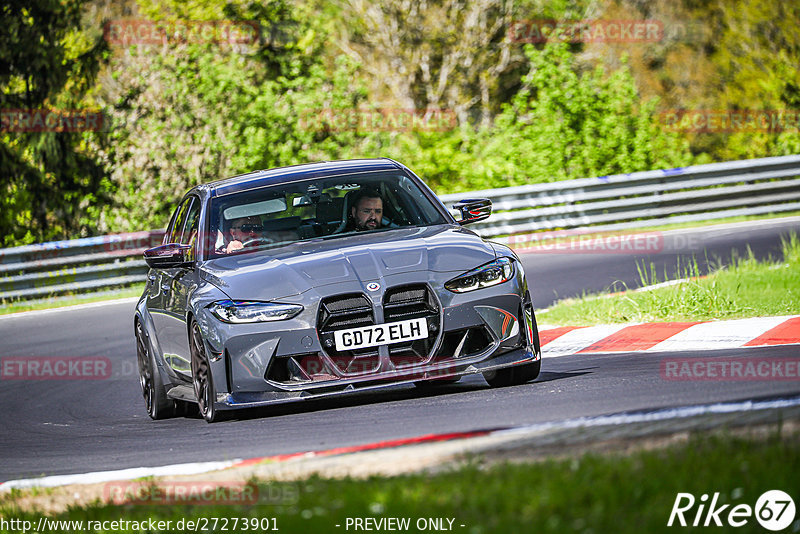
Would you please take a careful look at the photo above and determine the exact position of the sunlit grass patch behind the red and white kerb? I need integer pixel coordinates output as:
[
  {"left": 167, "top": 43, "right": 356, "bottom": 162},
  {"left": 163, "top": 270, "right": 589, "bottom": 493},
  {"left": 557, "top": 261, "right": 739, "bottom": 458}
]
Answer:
[{"left": 539, "top": 235, "right": 800, "bottom": 326}]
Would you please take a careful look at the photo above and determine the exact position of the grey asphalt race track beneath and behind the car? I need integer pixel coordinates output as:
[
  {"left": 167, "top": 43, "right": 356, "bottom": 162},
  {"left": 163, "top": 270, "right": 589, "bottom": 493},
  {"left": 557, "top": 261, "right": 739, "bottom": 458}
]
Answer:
[{"left": 0, "top": 219, "right": 800, "bottom": 481}]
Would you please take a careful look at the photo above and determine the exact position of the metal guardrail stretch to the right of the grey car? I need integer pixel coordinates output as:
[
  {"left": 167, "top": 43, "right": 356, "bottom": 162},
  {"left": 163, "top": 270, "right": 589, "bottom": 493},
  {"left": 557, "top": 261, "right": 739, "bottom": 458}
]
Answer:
[{"left": 439, "top": 155, "right": 800, "bottom": 244}]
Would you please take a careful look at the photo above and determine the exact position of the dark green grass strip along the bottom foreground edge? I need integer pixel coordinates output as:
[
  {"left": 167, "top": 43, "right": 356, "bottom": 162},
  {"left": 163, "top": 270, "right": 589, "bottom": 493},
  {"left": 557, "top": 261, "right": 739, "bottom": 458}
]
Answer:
[{"left": 0, "top": 429, "right": 800, "bottom": 534}]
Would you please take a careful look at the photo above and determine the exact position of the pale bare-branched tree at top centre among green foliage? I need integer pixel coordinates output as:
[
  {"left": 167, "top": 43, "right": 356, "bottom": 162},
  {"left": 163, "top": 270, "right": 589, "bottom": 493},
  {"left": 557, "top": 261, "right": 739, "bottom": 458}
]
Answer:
[{"left": 338, "top": 0, "right": 525, "bottom": 126}]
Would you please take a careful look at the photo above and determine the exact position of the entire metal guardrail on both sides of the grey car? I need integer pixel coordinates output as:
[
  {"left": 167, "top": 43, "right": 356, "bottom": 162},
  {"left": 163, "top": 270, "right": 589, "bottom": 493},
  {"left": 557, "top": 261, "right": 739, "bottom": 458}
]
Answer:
[{"left": 0, "top": 155, "right": 800, "bottom": 302}]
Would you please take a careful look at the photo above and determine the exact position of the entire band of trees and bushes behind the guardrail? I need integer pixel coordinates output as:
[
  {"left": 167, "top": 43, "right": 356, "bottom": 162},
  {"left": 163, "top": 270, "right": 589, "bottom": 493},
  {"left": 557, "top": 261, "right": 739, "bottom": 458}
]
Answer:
[{"left": 0, "top": 0, "right": 800, "bottom": 246}]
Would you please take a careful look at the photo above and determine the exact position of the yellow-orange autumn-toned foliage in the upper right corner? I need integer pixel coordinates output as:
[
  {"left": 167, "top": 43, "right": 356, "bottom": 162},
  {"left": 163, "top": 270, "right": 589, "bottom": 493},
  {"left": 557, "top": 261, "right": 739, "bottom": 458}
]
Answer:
[{"left": 586, "top": 0, "right": 800, "bottom": 163}]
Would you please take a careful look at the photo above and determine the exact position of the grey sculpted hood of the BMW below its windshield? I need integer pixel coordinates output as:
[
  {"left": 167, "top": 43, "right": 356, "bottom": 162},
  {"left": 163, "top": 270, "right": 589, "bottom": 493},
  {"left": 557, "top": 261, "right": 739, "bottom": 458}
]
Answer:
[{"left": 200, "top": 226, "right": 495, "bottom": 300}]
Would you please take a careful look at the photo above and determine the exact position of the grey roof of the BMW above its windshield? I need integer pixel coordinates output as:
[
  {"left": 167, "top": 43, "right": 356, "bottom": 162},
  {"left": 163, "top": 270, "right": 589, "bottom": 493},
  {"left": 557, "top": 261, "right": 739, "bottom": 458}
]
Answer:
[{"left": 199, "top": 158, "right": 405, "bottom": 201}]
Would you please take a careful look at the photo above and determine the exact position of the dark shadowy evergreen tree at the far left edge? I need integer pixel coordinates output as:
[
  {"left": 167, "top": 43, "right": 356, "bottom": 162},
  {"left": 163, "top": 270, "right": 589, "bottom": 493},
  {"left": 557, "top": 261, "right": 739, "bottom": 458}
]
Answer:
[{"left": 0, "top": 0, "right": 109, "bottom": 246}]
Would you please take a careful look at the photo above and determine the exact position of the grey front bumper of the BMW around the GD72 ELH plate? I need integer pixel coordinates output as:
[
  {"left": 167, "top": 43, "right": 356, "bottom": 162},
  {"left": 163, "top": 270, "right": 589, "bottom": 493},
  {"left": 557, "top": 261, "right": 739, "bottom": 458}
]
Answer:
[{"left": 199, "top": 262, "right": 540, "bottom": 410}]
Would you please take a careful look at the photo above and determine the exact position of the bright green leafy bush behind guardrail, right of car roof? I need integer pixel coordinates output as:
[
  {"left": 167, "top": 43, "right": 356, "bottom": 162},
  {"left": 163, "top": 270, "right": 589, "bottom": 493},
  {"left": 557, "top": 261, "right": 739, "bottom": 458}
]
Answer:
[{"left": 368, "top": 42, "right": 692, "bottom": 192}]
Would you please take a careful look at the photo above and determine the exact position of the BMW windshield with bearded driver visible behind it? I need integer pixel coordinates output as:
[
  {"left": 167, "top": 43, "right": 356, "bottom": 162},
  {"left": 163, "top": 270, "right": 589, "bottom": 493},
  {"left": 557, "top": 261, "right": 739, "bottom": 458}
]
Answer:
[{"left": 209, "top": 173, "right": 447, "bottom": 258}]
